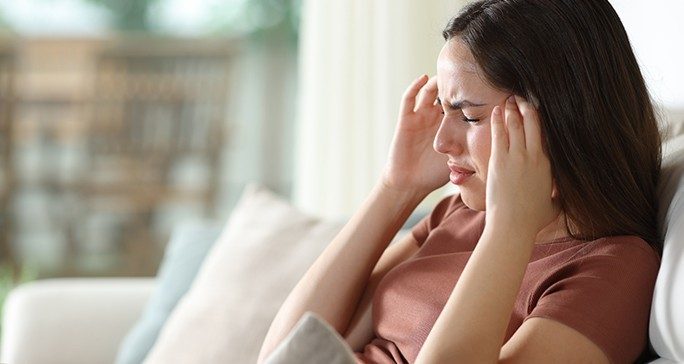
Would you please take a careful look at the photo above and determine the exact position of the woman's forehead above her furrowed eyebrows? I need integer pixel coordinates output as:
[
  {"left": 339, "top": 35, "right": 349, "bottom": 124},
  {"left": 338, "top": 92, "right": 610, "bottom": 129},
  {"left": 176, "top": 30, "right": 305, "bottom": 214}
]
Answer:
[{"left": 437, "top": 38, "right": 493, "bottom": 100}]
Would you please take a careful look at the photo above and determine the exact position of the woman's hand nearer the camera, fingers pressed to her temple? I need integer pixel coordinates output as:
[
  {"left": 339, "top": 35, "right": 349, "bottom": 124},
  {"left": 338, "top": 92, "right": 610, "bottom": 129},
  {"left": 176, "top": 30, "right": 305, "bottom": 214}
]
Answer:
[{"left": 486, "top": 96, "right": 560, "bottom": 238}]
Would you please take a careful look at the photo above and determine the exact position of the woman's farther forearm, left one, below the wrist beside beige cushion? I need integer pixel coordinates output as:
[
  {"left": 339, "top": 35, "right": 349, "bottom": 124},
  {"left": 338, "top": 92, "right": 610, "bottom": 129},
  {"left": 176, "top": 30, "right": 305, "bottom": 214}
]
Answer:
[{"left": 259, "top": 184, "right": 424, "bottom": 362}]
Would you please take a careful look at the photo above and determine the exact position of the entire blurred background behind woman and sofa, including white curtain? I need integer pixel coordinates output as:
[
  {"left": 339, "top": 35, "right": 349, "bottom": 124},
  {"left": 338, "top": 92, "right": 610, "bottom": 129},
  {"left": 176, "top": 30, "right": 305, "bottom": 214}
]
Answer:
[{"left": 0, "top": 0, "right": 684, "bottom": 318}]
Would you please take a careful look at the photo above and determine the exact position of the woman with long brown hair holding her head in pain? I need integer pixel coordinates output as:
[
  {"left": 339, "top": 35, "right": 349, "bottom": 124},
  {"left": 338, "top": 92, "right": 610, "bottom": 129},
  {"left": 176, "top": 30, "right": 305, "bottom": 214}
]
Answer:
[{"left": 260, "top": 0, "right": 660, "bottom": 363}]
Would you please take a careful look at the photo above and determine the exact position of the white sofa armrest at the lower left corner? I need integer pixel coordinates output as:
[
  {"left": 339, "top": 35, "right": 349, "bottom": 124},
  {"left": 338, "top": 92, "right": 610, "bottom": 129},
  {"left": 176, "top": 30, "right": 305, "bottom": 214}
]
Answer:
[{"left": 0, "top": 278, "right": 154, "bottom": 364}]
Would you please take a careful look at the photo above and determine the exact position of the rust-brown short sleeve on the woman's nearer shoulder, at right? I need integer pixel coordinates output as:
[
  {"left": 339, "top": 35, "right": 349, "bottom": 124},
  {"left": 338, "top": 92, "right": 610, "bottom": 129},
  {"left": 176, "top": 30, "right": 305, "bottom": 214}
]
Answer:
[{"left": 525, "top": 237, "right": 660, "bottom": 363}]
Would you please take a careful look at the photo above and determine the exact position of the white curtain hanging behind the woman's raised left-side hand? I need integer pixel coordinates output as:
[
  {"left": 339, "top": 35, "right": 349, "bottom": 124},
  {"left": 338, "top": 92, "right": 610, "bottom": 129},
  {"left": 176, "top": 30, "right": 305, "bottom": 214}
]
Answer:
[{"left": 293, "top": 0, "right": 467, "bottom": 218}]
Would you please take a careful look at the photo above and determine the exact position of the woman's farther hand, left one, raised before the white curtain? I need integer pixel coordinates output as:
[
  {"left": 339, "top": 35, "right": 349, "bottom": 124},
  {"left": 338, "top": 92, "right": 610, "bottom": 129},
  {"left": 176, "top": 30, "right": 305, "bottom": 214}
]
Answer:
[{"left": 382, "top": 75, "right": 449, "bottom": 195}]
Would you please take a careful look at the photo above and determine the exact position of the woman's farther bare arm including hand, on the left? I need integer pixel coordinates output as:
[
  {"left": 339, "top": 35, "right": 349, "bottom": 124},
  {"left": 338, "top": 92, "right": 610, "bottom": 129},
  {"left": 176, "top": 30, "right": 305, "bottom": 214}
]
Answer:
[{"left": 258, "top": 75, "right": 449, "bottom": 362}]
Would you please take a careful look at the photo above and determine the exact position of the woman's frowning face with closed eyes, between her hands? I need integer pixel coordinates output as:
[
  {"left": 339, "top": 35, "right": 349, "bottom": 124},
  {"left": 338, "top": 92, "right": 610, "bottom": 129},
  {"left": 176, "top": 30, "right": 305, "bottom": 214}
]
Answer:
[{"left": 433, "top": 38, "right": 510, "bottom": 211}]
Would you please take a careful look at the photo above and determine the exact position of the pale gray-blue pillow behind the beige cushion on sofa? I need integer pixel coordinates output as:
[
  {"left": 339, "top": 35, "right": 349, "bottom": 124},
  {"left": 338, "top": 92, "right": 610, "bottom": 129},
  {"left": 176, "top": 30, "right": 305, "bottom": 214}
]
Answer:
[{"left": 116, "top": 222, "right": 221, "bottom": 364}]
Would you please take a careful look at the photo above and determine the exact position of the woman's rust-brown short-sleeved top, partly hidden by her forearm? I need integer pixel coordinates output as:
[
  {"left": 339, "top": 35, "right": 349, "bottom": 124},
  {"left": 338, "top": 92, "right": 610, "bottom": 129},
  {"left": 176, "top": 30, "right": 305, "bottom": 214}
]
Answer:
[{"left": 355, "top": 195, "right": 660, "bottom": 363}]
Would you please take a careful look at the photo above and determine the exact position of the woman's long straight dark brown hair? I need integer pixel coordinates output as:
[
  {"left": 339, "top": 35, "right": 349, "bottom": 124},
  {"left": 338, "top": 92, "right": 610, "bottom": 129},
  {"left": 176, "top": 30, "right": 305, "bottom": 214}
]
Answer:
[{"left": 443, "top": 0, "right": 662, "bottom": 253}]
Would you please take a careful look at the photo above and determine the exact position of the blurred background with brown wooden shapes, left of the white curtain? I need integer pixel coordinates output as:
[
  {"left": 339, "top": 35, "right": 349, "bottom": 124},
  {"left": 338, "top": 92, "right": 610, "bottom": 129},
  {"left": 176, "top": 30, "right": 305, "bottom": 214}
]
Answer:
[{"left": 0, "top": 0, "right": 300, "bottom": 278}]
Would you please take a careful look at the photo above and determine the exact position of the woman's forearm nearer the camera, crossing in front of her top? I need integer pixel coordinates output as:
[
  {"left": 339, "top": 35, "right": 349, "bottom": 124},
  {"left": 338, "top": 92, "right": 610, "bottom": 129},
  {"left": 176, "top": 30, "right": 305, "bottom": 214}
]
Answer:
[{"left": 416, "top": 225, "right": 535, "bottom": 364}]
